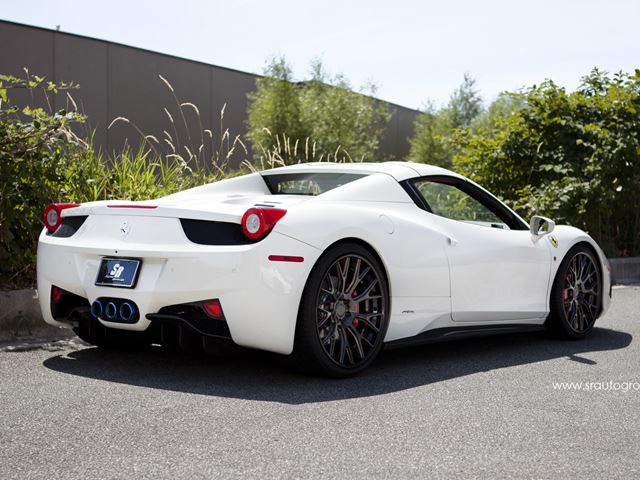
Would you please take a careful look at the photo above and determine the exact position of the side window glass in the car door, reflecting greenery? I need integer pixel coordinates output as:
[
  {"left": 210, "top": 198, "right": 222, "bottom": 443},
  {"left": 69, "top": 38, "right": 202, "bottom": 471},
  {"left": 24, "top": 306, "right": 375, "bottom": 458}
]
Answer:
[{"left": 414, "top": 180, "right": 509, "bottom": 230}]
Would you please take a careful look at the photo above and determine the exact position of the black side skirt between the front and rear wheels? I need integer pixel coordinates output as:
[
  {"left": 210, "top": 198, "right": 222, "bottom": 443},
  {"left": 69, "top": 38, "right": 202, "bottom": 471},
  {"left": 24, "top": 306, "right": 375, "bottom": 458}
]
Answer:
[{"left": 384, "top": 323, "right": 545, "bottom": 350}]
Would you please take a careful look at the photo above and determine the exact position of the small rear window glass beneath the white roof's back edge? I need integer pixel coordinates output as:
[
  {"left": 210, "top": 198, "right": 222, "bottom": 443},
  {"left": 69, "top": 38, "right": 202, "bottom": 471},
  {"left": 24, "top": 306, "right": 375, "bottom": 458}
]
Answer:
[{"left": 262, "top": 172, "right": 366, "bottom": 196}]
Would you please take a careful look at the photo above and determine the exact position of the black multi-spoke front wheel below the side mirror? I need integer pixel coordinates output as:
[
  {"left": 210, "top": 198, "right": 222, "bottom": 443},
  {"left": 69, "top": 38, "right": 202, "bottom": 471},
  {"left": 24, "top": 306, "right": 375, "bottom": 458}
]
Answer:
[{"left": 546, "top": 245, "right": 602, "bottom": 339}]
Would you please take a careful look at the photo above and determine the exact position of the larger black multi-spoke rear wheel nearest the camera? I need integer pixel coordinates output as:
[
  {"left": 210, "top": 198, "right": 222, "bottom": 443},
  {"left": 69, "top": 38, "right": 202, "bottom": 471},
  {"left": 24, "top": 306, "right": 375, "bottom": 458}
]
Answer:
[{"left": 293, "top": 243, "right": 389, "bottom": 377}]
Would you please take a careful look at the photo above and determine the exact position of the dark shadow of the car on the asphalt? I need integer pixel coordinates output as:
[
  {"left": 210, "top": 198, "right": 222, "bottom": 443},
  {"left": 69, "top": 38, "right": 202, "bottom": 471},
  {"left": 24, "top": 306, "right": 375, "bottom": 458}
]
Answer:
[{"left": 44, "top": 328, "right": 632, "bottom": 404}]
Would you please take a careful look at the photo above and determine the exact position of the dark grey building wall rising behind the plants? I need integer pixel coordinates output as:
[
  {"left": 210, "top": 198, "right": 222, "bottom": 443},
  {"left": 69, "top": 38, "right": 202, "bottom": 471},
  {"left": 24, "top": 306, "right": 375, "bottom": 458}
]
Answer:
[{"left": 0, "top": 21, "right": 417, "bottom": 164}]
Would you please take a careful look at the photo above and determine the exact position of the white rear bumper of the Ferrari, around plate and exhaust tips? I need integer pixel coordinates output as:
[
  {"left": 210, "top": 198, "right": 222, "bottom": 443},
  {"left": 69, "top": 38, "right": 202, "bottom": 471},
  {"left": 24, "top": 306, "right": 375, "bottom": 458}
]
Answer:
[{"left": 38, "top": 232, "right": 322, "bottom": 354}]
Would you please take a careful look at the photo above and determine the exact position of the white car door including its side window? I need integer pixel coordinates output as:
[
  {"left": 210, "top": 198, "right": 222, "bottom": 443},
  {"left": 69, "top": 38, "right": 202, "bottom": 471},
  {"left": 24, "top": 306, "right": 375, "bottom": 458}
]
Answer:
[{"left": 412, "top": 176, "right": 552, "bottom": 322}]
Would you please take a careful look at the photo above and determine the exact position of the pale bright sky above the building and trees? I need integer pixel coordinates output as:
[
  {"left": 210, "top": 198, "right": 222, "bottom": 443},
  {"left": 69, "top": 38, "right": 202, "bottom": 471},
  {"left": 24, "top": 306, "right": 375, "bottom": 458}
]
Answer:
[{"left": 0, "top": 0, "right": 640, "bottom": 108}]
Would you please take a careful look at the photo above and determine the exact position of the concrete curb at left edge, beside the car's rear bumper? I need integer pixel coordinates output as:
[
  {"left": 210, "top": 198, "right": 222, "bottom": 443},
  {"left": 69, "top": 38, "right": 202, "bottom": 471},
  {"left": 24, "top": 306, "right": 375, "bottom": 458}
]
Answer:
[{"left": 0, "top": 289, "right": 73, "bottom": 341}]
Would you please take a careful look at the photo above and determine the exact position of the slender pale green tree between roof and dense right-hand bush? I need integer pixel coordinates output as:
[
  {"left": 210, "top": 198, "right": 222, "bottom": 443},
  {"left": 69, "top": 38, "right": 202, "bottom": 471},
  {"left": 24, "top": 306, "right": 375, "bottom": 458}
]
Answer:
[{"left": 409, "top": 73, "right": 484, "bottom": 168}]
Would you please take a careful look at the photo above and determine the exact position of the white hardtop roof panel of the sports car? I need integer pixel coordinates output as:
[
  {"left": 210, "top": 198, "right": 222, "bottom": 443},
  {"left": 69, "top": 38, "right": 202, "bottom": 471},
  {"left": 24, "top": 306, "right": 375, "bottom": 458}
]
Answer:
[{"left": 260, "top": 162, "right": 462, "bottom": 182}]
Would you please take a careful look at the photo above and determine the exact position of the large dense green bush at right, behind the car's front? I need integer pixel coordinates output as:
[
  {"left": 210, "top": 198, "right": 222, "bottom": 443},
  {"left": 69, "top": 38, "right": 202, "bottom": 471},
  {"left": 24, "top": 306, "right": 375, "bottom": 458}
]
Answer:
[{"left": 453, "top": 69, "right": 640, "bottom": 256}]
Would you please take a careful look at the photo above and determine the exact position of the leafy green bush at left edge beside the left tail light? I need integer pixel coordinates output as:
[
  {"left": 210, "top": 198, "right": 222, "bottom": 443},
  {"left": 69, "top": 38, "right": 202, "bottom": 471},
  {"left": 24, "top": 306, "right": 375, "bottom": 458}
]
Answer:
[{"left": 0, "top": 75, "right": 86, "bottom": 286}]
